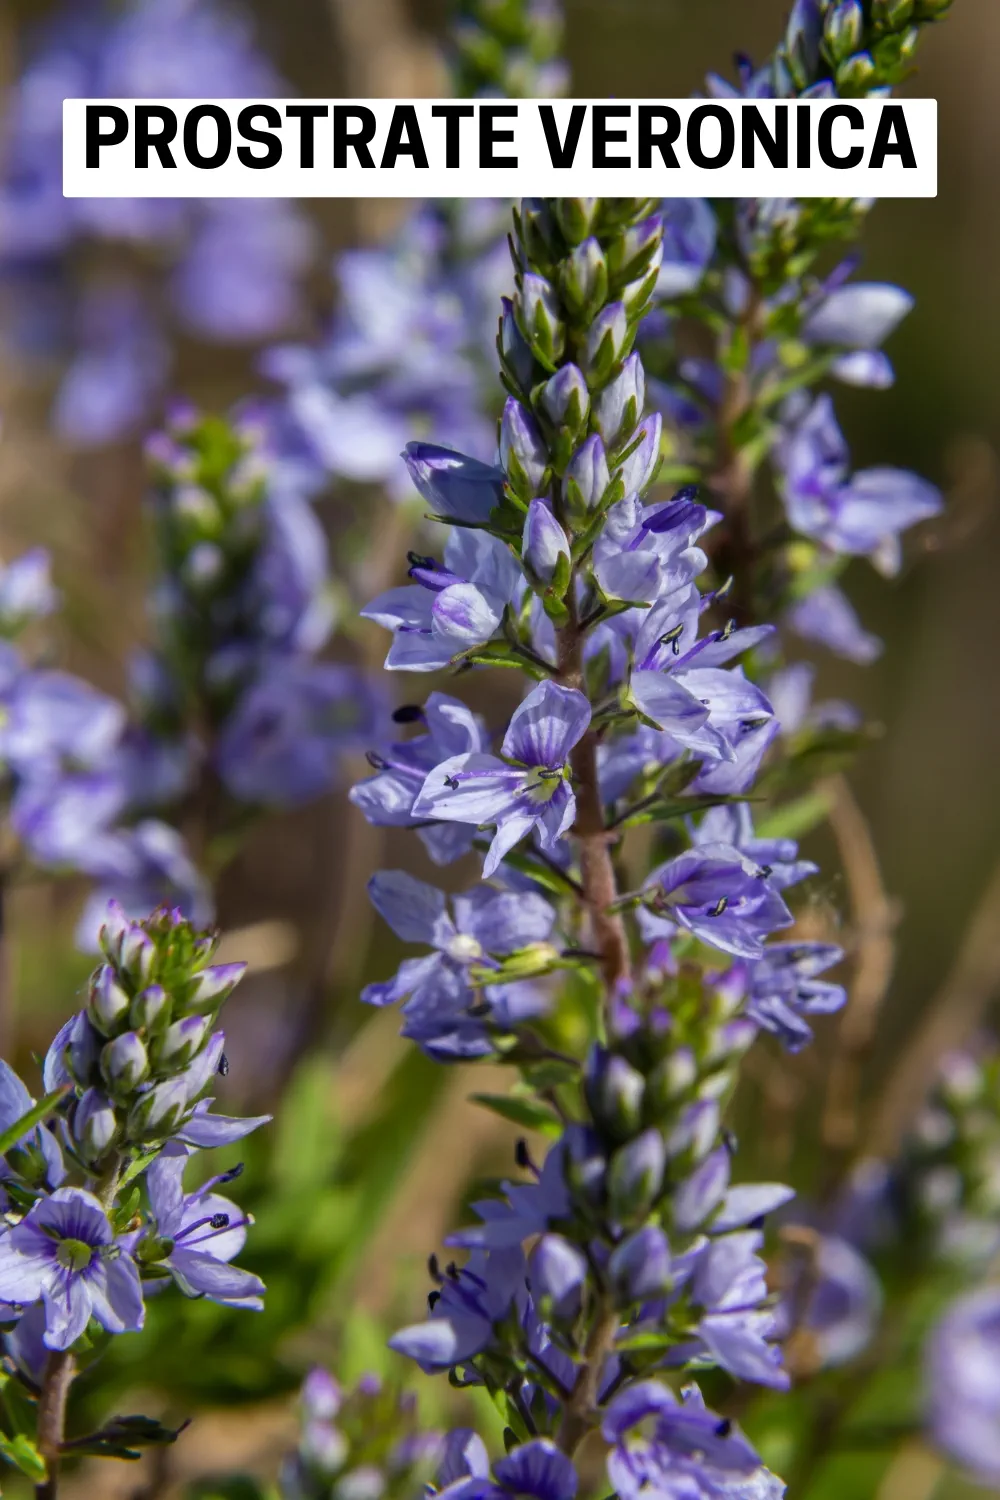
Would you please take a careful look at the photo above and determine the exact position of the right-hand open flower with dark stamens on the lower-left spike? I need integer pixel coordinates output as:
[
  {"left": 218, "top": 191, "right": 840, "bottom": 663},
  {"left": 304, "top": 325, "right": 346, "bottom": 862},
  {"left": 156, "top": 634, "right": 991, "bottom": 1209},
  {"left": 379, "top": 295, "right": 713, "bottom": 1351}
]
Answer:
[{"left": 145, "top": 1146, "right": 264, "bottom": 1313}]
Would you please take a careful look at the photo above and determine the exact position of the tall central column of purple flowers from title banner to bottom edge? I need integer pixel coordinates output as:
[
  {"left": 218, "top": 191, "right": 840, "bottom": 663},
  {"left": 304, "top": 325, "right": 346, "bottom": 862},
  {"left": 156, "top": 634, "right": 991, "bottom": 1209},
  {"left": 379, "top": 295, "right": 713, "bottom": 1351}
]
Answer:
[{"left": 354, "top": 200, "right": 843, "bottom": 1500}]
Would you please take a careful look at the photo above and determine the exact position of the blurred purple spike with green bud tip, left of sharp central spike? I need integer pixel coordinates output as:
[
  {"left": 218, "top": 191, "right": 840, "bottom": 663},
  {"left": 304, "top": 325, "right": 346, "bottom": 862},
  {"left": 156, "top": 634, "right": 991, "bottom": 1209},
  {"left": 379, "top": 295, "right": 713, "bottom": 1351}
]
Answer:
[{"left": 132, "top": 410, "right": 381, "bottom": 810}]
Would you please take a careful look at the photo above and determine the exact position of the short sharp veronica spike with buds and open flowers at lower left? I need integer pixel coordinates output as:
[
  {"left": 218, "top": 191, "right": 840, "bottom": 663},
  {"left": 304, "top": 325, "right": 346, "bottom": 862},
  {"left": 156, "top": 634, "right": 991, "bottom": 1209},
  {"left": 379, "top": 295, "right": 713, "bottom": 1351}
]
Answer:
[{"left": 0, "top": 905, "right": 265, "bottom": 1497}]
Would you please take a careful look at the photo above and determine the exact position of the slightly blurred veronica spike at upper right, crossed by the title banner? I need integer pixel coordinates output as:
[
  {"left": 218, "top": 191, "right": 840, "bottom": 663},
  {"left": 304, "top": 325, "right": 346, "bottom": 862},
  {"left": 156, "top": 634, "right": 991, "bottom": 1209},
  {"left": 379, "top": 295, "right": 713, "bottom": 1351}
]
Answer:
[{"left": 648, "top": 0, "right": 949, "bottom": 662}]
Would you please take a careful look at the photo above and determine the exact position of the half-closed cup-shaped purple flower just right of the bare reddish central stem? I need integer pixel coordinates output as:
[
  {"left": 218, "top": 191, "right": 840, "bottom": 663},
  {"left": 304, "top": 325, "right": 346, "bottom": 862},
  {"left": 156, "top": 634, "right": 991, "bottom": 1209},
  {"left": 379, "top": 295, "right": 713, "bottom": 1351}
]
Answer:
[{"left": 642, "top": 843, "right": 792, "bottom": 959}]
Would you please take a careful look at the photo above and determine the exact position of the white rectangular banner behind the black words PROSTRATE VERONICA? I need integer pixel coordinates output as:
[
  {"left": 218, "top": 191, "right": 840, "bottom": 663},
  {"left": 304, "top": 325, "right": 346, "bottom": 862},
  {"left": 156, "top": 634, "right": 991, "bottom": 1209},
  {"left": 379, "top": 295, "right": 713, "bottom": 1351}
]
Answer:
[{"left": 63, "top": 99, "right": 937, "bottom": 198}]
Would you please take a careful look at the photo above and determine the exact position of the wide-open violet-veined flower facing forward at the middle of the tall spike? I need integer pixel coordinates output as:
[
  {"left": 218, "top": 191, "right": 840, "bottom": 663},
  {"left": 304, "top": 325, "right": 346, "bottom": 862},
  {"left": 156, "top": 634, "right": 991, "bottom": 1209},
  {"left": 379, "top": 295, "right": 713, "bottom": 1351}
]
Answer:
[{"left": 414, "top": 683, "right": 591, "bottom": 878}]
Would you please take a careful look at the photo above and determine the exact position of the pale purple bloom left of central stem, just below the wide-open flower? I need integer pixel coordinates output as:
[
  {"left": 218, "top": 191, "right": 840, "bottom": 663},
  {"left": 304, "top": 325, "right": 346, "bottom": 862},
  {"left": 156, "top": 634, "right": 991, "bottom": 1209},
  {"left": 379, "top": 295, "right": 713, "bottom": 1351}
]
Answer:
[{"left": 361, "top": 870, "right": 555, "bottom": 1062}]
